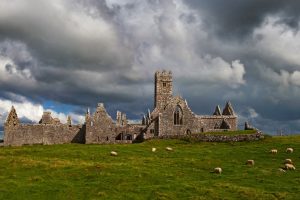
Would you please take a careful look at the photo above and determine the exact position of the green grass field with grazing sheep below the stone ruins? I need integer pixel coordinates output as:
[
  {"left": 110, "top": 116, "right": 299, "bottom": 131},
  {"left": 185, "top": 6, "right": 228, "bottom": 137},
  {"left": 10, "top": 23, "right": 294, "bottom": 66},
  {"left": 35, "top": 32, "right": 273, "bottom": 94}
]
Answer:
[{"left": 0, "top": 136, "right": 300, "bottom": 199}]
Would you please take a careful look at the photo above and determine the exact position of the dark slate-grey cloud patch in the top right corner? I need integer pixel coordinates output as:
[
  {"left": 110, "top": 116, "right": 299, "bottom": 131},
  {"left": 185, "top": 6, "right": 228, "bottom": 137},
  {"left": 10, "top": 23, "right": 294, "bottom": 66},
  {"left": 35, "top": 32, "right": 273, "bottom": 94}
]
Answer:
[{"left": 186, "top": 0, "right": 300, "bottom": 40}]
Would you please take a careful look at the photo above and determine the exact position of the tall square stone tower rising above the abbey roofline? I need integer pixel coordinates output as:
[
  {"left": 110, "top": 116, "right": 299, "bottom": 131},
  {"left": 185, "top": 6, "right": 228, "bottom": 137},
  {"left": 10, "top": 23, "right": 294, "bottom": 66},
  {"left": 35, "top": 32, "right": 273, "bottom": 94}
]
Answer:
[{"left": 154, "top": 70, "right": 173, "bottom": 109}]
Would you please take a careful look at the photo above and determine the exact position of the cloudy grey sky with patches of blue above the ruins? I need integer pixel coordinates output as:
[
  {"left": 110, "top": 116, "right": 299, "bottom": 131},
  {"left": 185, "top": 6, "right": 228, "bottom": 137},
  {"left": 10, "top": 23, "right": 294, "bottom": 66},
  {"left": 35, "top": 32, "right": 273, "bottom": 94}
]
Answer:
[{"left": 0, "top": 0, "right": 300, "bottom": 133}]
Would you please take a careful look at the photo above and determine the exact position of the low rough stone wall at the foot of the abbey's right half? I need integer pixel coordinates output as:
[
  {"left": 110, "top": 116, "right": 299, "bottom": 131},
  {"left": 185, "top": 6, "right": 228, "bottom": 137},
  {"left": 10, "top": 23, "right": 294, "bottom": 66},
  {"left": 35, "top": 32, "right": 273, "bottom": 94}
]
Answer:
[{"left": 152, "top": 131, "right": 264, "bottom": 142}]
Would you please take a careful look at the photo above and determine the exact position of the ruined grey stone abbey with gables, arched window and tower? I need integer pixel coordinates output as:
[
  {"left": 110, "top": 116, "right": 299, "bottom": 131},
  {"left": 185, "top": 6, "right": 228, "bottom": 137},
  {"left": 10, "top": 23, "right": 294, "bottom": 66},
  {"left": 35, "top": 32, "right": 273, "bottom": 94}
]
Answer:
[{"left": 3, "top": 71, "right": 237, "bottom": 146}]
